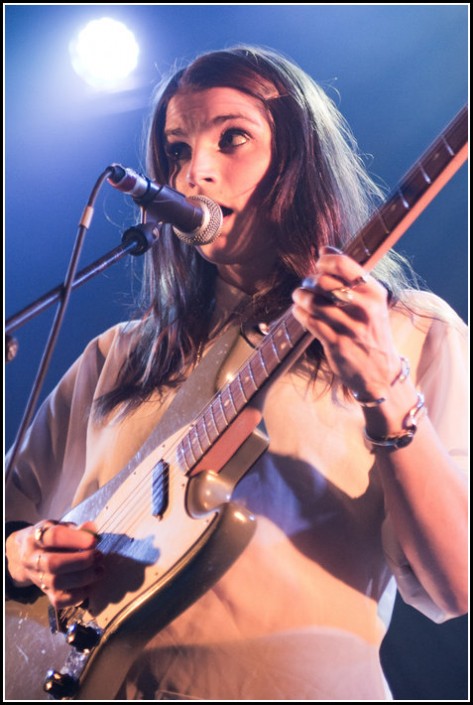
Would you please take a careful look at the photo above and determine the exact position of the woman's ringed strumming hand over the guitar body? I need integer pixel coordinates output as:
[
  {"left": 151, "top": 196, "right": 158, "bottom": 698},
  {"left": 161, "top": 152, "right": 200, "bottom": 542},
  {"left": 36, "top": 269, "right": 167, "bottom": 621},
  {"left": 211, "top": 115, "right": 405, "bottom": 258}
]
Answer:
[{"left": 6, "top": 520, "right": 104, "bottom": 609}]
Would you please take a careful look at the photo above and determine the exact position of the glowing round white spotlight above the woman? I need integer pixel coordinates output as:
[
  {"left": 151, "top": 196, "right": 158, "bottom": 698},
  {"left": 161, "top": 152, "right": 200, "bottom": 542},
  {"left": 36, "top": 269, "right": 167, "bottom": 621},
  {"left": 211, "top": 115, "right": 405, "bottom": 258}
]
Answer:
[{"left": 69, "top": 17, "right": 140, "bottom": 90}]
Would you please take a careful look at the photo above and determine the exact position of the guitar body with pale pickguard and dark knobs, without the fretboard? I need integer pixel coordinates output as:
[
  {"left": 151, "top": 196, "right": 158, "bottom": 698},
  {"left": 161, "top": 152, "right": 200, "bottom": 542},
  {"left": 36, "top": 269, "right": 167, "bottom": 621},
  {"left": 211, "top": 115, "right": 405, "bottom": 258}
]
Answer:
[{"left": 5, "top": 331, "right": 268, "bottom": 701}]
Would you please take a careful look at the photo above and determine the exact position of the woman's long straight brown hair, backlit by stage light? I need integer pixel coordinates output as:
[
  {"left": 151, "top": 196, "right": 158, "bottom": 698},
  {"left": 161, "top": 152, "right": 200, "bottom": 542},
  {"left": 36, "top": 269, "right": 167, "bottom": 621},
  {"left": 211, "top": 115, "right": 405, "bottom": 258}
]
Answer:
[{"left": 98, "top": 46, "right": 410, "bottom": 415}]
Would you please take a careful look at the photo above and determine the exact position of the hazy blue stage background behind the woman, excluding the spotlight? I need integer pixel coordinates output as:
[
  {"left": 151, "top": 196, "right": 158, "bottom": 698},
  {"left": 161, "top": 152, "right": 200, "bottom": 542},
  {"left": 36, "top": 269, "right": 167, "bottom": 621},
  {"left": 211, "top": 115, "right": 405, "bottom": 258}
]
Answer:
[{"left": 4, "top": 5, "right": 469, "bottom": 700}]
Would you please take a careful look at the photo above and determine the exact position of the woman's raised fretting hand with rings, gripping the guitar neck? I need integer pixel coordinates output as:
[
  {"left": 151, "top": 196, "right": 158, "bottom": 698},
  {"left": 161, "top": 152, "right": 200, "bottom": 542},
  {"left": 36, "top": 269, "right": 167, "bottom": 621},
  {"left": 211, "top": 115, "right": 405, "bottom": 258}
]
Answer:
[{"left": 293, "top": 247, "right": 400, "bottom": 399}]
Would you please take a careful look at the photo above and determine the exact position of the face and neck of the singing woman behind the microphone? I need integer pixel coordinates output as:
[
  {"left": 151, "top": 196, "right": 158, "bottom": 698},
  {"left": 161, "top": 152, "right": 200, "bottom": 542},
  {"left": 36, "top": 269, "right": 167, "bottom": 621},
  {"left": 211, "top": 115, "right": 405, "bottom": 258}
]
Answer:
[{"left": 165, "top": 88, "right": 274, "bottom": 284}]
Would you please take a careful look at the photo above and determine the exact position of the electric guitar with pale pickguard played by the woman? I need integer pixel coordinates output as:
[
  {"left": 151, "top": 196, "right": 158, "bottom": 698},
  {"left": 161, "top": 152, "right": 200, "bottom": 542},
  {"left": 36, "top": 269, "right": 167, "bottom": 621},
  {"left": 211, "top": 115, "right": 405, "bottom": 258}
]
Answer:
[{"left": 5, "top": 107, "right": 468, "bottom": 701}]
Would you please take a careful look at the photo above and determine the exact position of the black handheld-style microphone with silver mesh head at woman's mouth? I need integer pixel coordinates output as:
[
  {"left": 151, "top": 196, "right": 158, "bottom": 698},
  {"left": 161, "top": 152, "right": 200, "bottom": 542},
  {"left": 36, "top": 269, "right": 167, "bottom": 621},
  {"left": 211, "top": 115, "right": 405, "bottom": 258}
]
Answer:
[{"left": 107, "top": 164, "right": 223, "bottom": 245}]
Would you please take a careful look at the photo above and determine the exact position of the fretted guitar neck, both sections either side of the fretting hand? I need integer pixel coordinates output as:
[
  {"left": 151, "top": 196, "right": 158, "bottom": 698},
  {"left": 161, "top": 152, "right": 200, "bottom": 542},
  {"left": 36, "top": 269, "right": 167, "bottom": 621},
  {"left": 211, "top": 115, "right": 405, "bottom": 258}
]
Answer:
[{"left": 177, "top": 106, "right": 468, "bottom": 470}]
